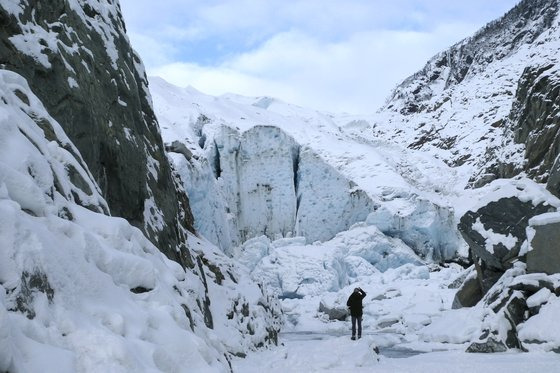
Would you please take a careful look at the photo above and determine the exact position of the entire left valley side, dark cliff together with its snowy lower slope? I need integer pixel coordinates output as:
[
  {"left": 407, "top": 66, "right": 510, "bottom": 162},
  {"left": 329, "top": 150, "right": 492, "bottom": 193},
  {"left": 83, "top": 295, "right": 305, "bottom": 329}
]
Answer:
[{"left": 0, "top": 0, "right": 282, "bottom": 372}]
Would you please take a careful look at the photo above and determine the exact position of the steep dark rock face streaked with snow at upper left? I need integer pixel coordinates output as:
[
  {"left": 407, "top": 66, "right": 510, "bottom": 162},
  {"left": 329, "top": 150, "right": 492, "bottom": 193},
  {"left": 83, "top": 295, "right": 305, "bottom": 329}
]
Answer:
[{"left": 0, "top": 0, "right": 192, "bottom": 262}]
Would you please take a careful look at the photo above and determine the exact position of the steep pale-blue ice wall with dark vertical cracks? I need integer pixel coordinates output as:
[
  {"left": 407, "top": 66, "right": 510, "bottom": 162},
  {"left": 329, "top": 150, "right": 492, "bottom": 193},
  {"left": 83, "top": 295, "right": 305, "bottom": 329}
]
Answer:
[{"left": 177, "top": 126, "right": 374, "bottom": 248}]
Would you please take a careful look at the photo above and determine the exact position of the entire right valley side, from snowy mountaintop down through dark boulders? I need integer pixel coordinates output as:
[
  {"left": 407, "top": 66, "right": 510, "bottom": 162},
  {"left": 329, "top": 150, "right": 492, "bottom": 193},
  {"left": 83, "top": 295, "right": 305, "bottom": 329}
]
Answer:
[{"left": 373, "top": 0, "right": 560, "bottom": 352}]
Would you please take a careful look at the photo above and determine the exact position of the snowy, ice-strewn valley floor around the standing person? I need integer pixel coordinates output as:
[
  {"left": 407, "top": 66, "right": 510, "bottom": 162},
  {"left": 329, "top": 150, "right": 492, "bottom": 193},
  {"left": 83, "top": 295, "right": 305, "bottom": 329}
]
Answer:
[{"left": 233, "top": 265, "right": 560, "bottom": 373}]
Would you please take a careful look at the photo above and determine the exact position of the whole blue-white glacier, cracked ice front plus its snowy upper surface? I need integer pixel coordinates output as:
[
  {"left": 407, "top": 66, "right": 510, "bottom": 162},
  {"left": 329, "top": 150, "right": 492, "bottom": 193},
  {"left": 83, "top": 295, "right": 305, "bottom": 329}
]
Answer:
[{"left": 150, "top": 78, "right": 465, "bottom": 259}]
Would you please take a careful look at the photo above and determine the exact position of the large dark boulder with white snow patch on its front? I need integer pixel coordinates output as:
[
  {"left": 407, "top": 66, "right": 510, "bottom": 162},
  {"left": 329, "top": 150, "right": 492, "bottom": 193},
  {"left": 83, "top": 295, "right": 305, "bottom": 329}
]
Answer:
[{"left": 458, "top": 197, "right": 551, "bottom": 304}]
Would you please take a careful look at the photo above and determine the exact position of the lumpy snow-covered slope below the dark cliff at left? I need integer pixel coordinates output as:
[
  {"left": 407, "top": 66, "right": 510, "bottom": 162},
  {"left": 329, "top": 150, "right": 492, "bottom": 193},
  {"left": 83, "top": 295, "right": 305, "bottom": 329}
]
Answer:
[{"left": 0, "top": 70, "right": 281, "bottom": 372}]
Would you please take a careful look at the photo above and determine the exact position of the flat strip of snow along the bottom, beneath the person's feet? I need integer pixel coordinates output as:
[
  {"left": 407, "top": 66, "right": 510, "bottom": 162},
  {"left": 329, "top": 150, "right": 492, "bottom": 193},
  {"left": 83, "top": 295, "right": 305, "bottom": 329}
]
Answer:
[{"left": 233, "top": 335, "right": 560, "bottom": 373}]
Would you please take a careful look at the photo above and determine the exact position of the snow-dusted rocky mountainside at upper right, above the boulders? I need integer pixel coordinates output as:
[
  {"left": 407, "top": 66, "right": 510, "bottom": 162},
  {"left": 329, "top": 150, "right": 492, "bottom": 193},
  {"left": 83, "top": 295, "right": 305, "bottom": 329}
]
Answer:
[{"left": 367, "top": 0, "right": 560, "bottom": 185}]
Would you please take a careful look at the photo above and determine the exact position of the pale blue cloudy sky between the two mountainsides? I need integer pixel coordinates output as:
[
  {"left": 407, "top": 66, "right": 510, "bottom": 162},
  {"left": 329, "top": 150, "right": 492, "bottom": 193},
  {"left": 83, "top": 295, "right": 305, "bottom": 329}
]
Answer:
[{"left": 120, "top": 0, "right": 518, "bottom": 114}]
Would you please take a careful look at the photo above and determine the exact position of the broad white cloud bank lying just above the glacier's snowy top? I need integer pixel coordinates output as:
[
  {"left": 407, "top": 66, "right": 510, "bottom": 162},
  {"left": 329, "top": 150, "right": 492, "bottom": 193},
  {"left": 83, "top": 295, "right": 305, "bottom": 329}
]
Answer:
[{"left": 151, "top": 25, "right": 472, "bottom": 113}]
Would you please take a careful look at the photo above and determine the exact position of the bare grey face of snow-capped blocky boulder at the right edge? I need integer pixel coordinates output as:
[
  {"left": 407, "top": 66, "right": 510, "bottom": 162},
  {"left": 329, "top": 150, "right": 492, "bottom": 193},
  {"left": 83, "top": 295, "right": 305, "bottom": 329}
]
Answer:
[{"left": 527, "top": 218, "right": 560, "bottom": 275}]
